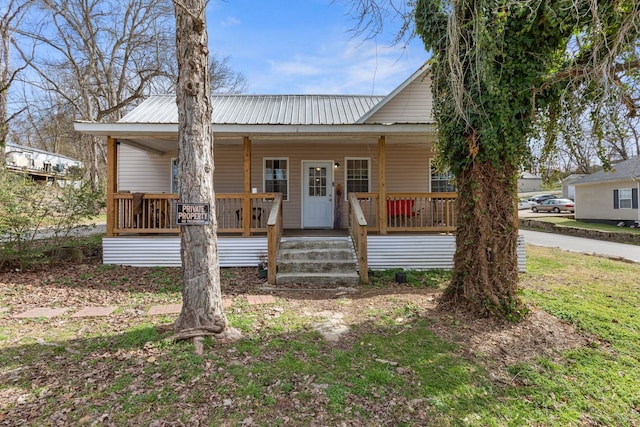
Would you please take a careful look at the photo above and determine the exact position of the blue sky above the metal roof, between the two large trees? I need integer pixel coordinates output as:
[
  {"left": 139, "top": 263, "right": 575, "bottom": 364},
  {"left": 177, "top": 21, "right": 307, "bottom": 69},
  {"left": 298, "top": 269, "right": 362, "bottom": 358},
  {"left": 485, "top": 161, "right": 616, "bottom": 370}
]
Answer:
[{"left": 207, "top": 0, "right": 428, "bottom": 95}]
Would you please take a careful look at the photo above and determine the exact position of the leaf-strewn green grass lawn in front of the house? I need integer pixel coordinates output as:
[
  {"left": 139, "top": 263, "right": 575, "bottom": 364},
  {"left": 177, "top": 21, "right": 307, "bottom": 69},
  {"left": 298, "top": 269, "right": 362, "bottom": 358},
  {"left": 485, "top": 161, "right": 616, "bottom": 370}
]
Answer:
[{"left": 0, "top": 247, "right": 640, "bottom": 426}]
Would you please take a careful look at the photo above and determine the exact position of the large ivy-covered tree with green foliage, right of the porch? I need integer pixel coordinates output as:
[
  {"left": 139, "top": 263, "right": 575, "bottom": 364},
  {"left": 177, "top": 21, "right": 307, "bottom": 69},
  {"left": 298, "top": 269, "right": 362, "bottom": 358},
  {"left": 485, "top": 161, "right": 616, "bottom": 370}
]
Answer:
[{"left": 415, "top": 0, "right": 640, "bottom": 320}]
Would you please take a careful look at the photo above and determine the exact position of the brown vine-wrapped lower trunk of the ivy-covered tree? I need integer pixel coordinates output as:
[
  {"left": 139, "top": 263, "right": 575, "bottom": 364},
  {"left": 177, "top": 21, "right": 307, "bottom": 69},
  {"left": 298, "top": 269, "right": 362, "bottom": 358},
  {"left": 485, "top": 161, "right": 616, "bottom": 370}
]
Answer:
[{"left": 441, "top": 155, "right": 526, "bottom": 320}]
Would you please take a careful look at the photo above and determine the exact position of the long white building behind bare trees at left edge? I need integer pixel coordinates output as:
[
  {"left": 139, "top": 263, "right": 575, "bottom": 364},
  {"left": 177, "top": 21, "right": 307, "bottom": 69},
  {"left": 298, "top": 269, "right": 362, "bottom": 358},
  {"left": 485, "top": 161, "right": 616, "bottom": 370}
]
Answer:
[{"left": 5, "top": 142, "right": 84, "bottom": 186}]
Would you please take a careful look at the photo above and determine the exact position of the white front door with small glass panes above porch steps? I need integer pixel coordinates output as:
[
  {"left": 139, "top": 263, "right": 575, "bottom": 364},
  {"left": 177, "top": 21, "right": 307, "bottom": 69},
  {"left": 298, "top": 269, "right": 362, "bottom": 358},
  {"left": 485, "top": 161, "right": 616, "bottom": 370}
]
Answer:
[{"left": 302, "top": 161, "right": 333, "bottom": 228}]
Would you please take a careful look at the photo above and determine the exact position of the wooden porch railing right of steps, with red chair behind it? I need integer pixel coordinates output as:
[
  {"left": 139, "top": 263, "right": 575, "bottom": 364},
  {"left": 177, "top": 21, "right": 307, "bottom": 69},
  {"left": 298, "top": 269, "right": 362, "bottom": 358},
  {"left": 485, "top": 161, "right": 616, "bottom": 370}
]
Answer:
[{"left": 355, "top": 193, "right": 457, "bottom": 234}]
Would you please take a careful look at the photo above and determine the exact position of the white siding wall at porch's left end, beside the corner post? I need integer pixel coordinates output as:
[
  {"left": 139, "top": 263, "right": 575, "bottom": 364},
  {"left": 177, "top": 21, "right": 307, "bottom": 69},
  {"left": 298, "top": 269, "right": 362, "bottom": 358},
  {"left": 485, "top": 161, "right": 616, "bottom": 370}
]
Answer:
[{"left": 118, "top": 143, "right": 175, "bottom": 193}]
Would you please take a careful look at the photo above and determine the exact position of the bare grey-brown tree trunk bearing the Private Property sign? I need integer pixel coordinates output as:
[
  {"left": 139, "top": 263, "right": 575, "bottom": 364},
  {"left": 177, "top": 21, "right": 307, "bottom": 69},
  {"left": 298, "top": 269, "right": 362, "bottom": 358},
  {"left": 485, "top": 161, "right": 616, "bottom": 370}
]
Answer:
[{"left": 174, "top": 0, "right": 239, "bottom": 340}]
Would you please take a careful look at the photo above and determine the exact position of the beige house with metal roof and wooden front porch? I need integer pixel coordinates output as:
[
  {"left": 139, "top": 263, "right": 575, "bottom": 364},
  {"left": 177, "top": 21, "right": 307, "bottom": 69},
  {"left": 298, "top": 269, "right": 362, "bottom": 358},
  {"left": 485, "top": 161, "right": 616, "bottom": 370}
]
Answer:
[{"left": 75, "top": 66, "right": 524, "bottom": 283}]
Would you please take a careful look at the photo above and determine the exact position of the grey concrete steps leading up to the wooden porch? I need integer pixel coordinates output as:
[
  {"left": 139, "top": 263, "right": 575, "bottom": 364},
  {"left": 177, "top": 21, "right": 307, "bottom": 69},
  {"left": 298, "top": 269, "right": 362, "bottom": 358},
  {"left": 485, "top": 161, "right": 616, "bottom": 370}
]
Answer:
[{"left": 276, "top": 238, "right": 360, "bottom": 287}]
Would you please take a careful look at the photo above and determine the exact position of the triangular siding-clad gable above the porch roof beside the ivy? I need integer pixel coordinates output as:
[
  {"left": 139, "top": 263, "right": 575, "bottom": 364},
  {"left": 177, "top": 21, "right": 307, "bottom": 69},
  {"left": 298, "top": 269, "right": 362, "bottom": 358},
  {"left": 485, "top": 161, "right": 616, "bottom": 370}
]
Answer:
[{"left": 367, "top": 75, "right": 433, "bottom": 123}]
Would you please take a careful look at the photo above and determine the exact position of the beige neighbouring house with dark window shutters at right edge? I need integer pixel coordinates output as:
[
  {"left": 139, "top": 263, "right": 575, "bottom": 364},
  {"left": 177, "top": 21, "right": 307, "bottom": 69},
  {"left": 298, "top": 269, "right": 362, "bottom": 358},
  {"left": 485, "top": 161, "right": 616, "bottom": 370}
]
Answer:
[{"left": 574, "top": 157, "right": 640, "bottom": 225}]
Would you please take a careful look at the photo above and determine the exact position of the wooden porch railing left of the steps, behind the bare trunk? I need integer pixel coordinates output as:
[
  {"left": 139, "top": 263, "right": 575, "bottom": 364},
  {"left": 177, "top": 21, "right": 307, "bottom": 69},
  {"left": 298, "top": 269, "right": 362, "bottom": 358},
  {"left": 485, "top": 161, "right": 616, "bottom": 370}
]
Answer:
[{"left": 112, "top": 193, "right": 277, "bottom": 236}]
